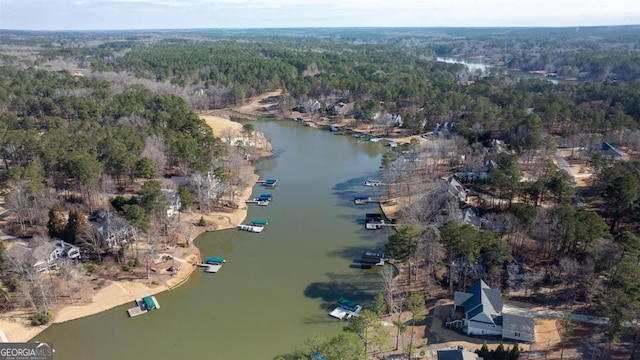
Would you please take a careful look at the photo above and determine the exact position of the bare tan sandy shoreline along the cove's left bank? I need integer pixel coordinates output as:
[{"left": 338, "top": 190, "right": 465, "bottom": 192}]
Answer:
[{"left": 0, "top": 115, "right": 258, "bottom": 342}]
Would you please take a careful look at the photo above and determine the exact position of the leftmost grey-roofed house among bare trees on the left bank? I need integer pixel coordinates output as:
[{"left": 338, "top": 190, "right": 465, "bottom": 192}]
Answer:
[{"left": 7, "top": 240, "right": 80, "bottom": 272}]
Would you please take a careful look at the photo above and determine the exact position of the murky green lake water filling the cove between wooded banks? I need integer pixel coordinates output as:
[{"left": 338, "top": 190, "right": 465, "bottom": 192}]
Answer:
[{"left": 34, "top": 121, "right": 390, "bottom": 360}]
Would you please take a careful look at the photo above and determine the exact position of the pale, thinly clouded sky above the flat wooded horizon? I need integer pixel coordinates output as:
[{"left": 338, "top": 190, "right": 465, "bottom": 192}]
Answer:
[{"left": 0, "top": 0, "right": 640, "bottom": 30}]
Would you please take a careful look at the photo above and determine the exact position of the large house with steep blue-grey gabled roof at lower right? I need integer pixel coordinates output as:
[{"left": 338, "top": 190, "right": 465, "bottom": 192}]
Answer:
[{"left": 450, "top": 279, "right": 534, "bottom": 342}]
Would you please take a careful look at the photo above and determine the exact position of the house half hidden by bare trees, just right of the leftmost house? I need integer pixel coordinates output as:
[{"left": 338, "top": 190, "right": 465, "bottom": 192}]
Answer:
[{"left": 89, "top": 209, "right": 136, "bottom": 248}]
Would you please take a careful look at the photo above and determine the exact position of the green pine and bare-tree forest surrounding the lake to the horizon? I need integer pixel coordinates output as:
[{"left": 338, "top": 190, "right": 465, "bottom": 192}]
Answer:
[{"left": 0, "top": 26, "right": 640, "bottom": 359}]
